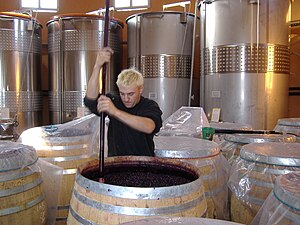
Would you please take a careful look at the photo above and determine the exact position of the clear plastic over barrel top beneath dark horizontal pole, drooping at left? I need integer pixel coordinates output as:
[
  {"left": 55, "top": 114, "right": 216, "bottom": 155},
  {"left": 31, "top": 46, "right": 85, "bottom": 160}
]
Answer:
[{"left": 219, "top": 134, "right": 296, "bottom": 164}]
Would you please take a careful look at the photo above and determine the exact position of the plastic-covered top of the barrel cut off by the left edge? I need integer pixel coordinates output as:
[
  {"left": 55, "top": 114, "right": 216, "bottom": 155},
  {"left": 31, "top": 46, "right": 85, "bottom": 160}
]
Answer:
[{"left": 0, "top": 141, "right": 38, "bottom": 172}]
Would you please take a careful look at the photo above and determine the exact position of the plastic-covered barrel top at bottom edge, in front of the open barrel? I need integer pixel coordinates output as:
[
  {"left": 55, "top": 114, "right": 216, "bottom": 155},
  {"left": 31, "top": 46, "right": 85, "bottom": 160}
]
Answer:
[{"left": 121, "top": 217, "right": 243, "bottom": 225}]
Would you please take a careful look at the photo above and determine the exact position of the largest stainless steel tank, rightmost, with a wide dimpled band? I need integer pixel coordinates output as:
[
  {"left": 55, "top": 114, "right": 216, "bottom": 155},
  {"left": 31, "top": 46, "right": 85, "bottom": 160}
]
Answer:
[{"left": 201, "top": 0, "right": 290, "bottom": 129}]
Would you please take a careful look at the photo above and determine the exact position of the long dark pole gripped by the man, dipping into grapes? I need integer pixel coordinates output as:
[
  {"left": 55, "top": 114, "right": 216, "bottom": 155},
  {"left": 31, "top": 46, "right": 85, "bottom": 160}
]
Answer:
[{"left": 99, "top": 0, "right": 109, "bottom": 183}]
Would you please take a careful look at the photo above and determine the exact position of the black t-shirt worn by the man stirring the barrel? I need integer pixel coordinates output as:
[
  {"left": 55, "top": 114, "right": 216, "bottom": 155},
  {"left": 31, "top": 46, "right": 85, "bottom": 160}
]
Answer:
[{"left": 84, "top": 94, "right": 162, "bottom": 156}]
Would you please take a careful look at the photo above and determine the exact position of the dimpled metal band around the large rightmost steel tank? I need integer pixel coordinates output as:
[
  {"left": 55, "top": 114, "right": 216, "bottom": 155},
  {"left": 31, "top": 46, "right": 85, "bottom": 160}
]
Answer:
[{"left": 205, "top": 44, "right": 290, "bottom": 74}]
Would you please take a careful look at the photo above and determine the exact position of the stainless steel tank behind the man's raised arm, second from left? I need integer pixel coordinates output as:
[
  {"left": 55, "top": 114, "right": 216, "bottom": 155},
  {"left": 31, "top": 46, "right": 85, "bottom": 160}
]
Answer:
[{"left": 47, "top": 14, "right": 123, "bottom": 124}]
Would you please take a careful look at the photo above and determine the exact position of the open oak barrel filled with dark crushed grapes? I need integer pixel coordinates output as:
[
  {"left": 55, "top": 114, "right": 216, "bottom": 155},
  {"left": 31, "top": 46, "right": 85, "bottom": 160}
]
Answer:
[{"left": 68, "top": 156, "right": 207, "bottom": 224}]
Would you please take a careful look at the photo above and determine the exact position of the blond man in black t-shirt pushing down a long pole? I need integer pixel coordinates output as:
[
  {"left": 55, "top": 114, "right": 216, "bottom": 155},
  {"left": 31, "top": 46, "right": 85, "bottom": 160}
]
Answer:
[{"left": 84, "top": 47, "right": 162, "bottom": 156}]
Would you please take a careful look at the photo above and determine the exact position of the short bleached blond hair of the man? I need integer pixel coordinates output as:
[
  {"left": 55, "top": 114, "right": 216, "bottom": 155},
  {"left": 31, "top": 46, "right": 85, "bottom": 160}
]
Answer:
[{"left": 116, "top": 68, "right": 144, "bottom": 87}]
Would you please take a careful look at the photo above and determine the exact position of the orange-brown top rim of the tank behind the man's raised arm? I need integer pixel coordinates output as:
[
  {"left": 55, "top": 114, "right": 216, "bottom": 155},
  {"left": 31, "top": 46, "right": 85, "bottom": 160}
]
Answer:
[{"left": 47, "top": 13, "right": 124, "bottom": 28}]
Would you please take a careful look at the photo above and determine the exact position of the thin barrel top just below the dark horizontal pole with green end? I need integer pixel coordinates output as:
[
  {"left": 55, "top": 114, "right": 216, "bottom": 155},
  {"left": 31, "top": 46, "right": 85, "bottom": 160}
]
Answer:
[{"left": 224, "top": 134, "right": 296, "bottom": 144}]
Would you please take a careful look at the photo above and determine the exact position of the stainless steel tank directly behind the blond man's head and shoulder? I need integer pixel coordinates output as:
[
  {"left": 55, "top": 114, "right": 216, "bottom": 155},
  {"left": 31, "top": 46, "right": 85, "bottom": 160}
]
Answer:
[{"left": 126, "top": 11, "right": 199, "bottom": 120}]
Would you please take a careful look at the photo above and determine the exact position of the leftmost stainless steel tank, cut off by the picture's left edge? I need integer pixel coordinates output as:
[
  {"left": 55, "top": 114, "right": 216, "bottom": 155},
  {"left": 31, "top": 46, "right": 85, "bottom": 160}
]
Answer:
[{"left": 0, "top": 12, "right": 42, "bottom": 133}]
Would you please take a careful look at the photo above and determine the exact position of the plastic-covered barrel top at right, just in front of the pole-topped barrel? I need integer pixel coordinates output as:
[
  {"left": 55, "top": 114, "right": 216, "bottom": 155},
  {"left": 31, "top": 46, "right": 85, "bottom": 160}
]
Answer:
[{"left": 240, "top": 142, "right": 300, "bottom": 167}]
